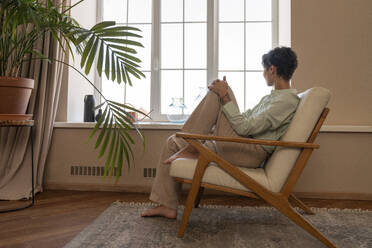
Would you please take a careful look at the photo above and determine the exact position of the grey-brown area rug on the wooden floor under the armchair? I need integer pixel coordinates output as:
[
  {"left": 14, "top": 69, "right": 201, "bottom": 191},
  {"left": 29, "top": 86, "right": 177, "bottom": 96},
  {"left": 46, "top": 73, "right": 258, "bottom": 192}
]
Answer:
[{"left": 65, "top": 202, "right": 372, "bottom": 248}]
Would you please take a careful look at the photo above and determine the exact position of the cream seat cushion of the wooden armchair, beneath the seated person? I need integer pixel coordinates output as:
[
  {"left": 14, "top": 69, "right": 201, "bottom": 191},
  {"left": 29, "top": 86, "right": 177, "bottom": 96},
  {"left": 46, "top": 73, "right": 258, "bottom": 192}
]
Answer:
[{"left": 169, "top": 158, "right": 269, "bottom": 191}]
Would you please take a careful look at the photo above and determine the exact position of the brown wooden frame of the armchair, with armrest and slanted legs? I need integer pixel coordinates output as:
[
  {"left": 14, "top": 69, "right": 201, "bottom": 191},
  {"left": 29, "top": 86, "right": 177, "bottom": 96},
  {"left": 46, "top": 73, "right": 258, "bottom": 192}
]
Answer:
[{"left": 175, "top": 108, "right": 336, "bottom": 247}]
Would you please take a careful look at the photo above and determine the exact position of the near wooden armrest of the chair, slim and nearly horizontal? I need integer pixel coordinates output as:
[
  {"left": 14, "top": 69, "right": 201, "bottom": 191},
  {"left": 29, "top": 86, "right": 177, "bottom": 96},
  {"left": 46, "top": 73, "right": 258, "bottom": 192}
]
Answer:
[{"left": 176, "top": 132, "right": 320, "bottom": 149}]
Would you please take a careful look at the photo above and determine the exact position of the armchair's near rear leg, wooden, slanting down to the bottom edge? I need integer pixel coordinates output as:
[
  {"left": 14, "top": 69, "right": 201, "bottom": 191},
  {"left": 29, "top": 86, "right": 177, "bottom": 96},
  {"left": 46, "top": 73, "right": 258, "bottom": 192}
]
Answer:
[{"left": 275, "top": 200, "right": 336, "bottom": 248}]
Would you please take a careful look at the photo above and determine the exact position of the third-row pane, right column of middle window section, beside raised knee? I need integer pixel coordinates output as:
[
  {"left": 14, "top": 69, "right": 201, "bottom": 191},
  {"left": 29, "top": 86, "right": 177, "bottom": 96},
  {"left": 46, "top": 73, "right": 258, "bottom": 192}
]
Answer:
[{"left": 184, "top": 70, "right": 208, "bottom": 114}]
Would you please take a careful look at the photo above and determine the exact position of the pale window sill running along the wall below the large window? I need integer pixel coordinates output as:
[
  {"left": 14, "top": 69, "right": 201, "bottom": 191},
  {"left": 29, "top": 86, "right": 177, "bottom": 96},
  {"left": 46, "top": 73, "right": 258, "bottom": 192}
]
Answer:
[{"left": 54, "top": 121, "right": 372, "bottom": 133}]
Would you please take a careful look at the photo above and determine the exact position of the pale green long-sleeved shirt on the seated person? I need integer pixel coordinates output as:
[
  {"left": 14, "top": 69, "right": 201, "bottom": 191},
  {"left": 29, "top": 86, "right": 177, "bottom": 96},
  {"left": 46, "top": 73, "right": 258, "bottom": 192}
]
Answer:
[{"left": 222, "top": 89, "right": 300, "bottom": 153}]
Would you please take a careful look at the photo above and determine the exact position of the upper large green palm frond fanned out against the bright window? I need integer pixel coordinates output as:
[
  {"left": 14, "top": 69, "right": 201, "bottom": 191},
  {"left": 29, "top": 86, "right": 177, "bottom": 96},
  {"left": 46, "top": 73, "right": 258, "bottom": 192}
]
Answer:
[{"left": 69, "top": 21, "right": 145, "bottom": 83}]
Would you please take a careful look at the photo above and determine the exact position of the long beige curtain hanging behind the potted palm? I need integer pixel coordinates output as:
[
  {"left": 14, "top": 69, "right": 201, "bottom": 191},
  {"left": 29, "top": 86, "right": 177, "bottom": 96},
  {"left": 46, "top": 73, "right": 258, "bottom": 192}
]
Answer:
[{"left": 0, "top": 0, "right": 68, "bottom": 200}]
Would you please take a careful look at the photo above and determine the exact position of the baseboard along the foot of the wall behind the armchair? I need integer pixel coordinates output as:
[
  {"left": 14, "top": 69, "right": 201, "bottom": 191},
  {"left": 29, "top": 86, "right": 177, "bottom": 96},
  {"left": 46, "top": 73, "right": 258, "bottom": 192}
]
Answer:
[{"left": 44, "top": 183, "right": 372, "bottom": 200}]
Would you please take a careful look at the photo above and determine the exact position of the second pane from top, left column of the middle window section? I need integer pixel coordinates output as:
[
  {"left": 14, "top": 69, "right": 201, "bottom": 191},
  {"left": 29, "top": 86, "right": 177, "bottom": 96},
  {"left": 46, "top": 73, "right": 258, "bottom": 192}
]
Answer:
[{"left": 161, "top": 24, "right": 183, "bottom": 68}]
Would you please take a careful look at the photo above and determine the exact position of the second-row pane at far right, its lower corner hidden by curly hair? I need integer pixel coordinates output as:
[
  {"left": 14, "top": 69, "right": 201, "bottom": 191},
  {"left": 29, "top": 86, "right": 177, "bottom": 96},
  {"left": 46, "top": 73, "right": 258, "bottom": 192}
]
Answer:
[{"left": 246, "top": 23, "right": 272, "bottom": 70}]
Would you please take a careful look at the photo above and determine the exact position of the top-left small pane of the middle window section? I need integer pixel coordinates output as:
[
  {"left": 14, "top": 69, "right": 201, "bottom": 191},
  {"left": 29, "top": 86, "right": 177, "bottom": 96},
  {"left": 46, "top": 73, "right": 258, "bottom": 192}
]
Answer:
[{"left": 161, "top": 0, "right": 183, "bottom": 22}]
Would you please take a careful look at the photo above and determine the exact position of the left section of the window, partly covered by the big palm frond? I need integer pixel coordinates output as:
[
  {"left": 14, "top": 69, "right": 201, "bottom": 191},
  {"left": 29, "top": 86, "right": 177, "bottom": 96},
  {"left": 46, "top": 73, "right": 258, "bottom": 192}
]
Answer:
[{"left": 100, "top": 0, "right": 152, "bottom": 112}]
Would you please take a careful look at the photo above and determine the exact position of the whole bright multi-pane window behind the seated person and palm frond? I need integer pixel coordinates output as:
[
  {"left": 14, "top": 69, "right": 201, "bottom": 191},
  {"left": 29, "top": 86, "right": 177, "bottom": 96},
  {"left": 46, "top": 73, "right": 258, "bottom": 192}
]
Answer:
[{"left": 97, "top": 0, "right": 278, "bottom": 121}]
